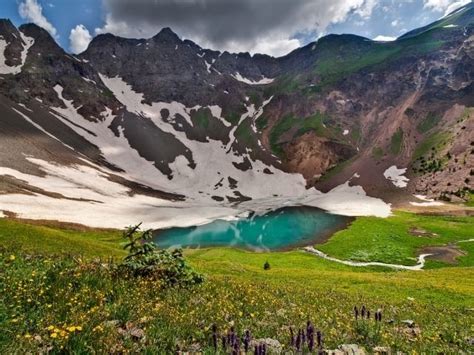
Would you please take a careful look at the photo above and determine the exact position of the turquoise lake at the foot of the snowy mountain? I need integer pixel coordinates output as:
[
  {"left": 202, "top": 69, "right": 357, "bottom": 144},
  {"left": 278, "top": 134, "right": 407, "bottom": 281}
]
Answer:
[{"left": 154, "top": 207, "right": 351, "bottom": 251}]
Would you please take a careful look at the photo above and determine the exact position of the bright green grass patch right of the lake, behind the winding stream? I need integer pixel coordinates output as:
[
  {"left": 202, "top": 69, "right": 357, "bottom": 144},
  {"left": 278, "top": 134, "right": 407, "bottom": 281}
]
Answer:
[{"left": 319, "top": 212, "right": 474, "bottom": 268}]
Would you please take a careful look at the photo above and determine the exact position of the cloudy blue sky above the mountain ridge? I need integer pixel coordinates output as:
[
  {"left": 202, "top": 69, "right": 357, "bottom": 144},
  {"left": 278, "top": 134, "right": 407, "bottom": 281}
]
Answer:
[{"left": 0, "top": 0, "right": 471, "bottom": 56}]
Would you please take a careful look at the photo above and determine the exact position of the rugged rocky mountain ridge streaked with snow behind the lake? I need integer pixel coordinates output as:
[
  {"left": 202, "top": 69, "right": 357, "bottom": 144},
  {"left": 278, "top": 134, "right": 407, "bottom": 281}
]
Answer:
[{"left": 0, "top": 4, "right": 474, "bottom": 227}]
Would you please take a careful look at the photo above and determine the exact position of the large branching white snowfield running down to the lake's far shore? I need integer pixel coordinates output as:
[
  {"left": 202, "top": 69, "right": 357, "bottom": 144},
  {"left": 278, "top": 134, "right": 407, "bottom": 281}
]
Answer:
[{"left": 0, "top": 75, "right": 390, "bottom": 229}]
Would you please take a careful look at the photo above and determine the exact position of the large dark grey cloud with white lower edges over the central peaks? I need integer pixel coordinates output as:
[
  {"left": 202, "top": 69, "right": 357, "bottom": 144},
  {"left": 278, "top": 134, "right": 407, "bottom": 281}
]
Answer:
[{"left": 95, "top": 0, "right": 380, "bottom": 56}]
